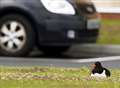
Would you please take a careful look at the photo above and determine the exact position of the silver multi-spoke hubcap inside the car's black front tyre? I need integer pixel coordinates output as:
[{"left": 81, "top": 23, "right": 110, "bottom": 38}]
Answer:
[{"left": 0, "top": 21, "right": 26, "bottom": 52}]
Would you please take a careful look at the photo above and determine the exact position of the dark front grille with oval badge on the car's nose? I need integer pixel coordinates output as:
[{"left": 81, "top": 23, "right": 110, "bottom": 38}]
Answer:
[{"left": 77, "top": 4, "right": 96, "bottom": 14}]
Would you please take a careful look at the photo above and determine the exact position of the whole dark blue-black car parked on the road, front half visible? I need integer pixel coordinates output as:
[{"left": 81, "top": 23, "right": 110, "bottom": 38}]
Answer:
[{"left": 0, "top": 0, "right": 100, "bottom": 57}]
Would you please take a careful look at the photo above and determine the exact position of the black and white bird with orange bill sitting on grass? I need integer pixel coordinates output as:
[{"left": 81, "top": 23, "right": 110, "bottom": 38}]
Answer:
[{"left": 91, "top": 62, "right": 111, "bottom": 78}]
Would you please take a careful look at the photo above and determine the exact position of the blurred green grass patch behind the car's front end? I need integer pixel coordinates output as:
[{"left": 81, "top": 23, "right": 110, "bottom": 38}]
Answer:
[{"left": 97, "top": 19, "right": 120, "bottom": 44}]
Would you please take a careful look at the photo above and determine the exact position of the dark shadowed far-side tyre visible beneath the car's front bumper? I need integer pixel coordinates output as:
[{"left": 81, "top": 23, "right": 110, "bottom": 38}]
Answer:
[{"left": 39, "top": 46, "right": 70, "bottom": 55}]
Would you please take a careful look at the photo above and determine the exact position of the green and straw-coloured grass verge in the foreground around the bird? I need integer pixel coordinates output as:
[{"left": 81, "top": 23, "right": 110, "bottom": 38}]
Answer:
[{"left": 0, "top": 67, "right": 120, "bottom": 88}]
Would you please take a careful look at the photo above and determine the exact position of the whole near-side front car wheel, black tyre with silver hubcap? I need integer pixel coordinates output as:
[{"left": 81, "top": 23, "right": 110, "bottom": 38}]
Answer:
[{"left": 0, "top": 14, "right": 35, "bottom": 57}]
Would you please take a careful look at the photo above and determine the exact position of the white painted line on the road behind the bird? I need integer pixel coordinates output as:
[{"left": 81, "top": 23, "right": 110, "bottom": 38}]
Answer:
[{"left": 72, "top": 56, "right": 120, "bottom": 63}]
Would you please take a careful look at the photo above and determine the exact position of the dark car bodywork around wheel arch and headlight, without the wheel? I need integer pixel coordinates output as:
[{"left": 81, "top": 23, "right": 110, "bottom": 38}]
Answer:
[{"left": 0, "top": 0, "right": 99, "bottom": 46}]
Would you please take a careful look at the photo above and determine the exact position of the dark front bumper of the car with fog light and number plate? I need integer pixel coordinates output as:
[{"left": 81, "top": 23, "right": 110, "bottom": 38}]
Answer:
[{"left": 39, "top": 14, "right": 100, "bottom": 45}]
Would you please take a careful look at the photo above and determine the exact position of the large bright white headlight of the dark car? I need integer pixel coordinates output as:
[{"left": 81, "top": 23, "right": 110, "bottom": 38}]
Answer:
[{"left": 41, "top": 0, "right": 75, "bottom": 15}]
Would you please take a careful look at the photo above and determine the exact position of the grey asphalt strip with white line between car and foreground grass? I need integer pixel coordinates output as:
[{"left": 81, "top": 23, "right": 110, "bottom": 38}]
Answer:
[{"left": 0, "top": 52, "right": 120, "bottom": 68}]
